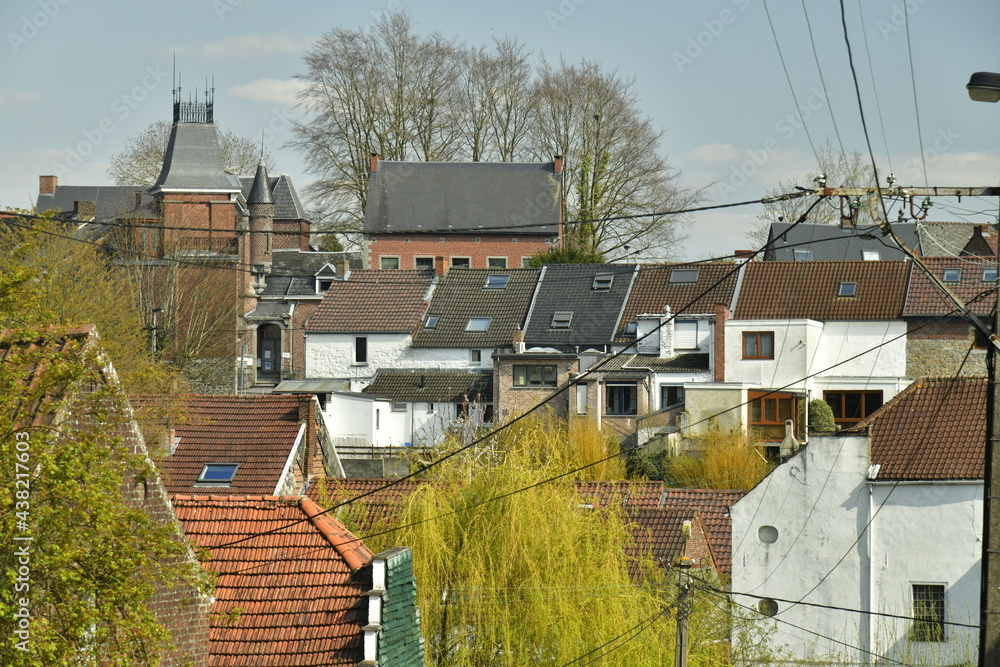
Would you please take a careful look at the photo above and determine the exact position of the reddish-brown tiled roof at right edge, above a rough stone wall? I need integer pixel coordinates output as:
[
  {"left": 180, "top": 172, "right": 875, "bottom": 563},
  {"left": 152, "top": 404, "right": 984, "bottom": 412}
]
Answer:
[{"left": 903, "top": 257, "right": 997, "bottom": 317}]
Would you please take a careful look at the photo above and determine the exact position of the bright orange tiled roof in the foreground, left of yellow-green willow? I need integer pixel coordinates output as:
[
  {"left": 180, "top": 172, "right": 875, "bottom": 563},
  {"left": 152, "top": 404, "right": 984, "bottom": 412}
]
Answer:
[{"left": 171, "top": 495, "right": 372, "bottom": 667}]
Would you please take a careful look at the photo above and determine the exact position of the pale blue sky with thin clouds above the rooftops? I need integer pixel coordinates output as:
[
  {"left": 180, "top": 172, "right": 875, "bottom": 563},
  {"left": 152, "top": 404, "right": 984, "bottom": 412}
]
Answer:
[{"left": 0, "top": 0, "right": 1000, "bottom": 259}]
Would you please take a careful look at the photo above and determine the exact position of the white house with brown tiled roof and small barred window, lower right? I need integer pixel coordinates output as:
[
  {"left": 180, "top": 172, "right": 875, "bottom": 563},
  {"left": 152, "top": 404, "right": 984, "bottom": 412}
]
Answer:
[{"left": 730, "top": 379, "right": 986, "bottom": 665}]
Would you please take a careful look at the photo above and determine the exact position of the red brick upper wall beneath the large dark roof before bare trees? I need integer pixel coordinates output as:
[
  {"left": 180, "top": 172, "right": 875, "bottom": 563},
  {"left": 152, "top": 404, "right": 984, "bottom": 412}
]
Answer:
[{"left": 365, "top": 234, "right": 551, "bottom": 269}]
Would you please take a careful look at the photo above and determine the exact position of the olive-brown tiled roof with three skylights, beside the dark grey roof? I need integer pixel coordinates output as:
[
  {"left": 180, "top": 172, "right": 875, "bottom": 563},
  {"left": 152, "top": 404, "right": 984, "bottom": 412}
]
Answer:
[{"left": 413, "top": 269, "right": 541, "bottom": 348}]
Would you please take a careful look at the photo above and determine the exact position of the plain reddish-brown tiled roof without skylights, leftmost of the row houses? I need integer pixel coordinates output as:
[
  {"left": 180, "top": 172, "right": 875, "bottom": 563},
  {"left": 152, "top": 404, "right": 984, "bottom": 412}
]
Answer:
[{"left": 306, "top": 269, "right": 434, "bottom": 333}]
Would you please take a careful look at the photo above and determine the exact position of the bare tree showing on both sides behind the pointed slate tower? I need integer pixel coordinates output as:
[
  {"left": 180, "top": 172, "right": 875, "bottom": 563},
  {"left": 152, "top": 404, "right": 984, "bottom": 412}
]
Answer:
[{"left": 106, "top": 120, "right": 272, "bottom": 185}]
